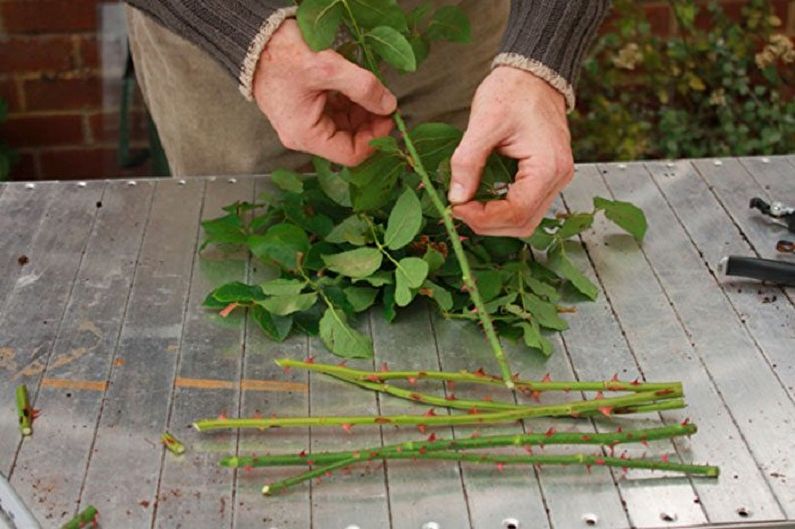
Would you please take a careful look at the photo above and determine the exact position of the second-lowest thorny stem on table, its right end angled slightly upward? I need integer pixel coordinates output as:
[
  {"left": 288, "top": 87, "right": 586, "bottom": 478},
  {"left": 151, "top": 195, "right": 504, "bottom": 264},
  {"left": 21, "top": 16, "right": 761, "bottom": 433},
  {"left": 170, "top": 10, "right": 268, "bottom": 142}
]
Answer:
[{"left": 219, "top": 423, "right": 698, "bottom": 468}]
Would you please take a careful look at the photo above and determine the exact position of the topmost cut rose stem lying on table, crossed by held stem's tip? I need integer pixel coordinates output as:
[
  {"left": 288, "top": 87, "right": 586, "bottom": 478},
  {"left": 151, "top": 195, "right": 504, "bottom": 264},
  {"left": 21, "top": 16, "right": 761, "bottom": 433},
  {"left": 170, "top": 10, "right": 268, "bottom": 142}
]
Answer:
[{"left": 276, "top": 358, "right": 682, "bottom": 393}]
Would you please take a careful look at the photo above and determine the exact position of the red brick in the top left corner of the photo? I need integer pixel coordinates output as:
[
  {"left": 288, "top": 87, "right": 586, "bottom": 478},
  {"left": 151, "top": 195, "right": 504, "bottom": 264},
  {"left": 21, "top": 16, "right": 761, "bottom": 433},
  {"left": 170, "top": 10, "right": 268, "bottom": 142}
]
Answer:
[{"left": 0, "top": 0, "right": 98, "bottom": 34}]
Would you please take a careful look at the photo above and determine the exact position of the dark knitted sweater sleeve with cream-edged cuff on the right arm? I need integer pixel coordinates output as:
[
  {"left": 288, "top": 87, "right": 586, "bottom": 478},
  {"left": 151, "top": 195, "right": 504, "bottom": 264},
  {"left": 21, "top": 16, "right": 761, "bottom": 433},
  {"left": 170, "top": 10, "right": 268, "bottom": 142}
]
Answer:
[{"left": 500, "top": 0, "right": 610, "bottom": 110}]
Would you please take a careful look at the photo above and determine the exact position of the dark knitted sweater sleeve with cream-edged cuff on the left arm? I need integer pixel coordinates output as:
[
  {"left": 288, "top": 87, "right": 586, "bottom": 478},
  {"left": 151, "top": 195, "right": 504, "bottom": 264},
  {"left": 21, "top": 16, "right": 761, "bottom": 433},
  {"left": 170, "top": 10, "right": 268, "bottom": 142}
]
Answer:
[{"left": 127, "top": 0, "right": 296, "bottom": 99}]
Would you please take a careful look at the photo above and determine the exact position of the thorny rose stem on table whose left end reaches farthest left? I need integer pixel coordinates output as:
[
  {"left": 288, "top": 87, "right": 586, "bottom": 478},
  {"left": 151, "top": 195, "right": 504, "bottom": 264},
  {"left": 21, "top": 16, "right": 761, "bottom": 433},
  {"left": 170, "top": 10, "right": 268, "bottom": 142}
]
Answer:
[{"left": 193, "top": 389, "right": 682, "bottom": 432}]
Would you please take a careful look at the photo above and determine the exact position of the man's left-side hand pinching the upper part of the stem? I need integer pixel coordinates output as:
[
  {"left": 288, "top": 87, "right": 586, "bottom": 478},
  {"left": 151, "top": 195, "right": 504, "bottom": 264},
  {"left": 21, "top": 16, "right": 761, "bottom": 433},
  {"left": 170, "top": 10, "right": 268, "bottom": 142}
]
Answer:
[{"left": 253, "top": 20, "right": 397, "bottom": 166}]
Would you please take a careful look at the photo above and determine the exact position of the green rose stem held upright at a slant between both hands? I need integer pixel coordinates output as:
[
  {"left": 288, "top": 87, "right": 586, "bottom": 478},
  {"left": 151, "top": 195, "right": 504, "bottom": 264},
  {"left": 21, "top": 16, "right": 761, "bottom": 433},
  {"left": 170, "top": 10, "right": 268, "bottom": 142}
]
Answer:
[{"left": 342, "top": 7, "right": 514, "bottom": 389}]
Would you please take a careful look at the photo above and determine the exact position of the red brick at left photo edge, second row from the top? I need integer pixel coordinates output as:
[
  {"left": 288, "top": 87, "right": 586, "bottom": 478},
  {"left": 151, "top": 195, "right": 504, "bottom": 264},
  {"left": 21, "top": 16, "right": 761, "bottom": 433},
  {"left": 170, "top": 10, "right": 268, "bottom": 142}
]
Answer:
[{"left": 0, "top": 36, "right": 75, "bottom": 73}]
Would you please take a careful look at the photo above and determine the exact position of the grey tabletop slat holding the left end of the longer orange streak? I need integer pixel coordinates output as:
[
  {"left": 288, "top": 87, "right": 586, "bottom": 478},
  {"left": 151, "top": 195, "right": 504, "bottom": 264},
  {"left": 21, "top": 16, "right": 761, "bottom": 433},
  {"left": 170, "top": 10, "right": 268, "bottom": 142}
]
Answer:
[{"left": 154, "top": 178, "right": 254, "bottom": 529}]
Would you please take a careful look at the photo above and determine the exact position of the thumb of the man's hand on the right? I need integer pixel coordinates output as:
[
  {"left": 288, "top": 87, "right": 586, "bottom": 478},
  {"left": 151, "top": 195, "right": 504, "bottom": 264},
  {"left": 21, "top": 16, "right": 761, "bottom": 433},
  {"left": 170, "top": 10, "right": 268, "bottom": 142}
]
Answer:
[{"left": 447, "top": 124, "right": 499, "bottom": 204}]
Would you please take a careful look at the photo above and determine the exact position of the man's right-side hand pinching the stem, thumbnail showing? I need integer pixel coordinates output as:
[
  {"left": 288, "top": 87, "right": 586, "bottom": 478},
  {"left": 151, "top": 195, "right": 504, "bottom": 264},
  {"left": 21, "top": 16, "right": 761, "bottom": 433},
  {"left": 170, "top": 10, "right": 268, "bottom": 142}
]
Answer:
[{"left": 448, "top": 66, "right": 574, "bottom": 237}]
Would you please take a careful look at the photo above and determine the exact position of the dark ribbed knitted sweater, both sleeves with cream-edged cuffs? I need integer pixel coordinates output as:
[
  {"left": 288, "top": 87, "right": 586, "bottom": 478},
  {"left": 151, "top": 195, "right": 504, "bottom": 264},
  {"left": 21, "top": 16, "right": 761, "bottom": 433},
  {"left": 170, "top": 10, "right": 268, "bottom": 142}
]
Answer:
[{"left": 127, "top": 0, "right": 610, "bottom": 108}]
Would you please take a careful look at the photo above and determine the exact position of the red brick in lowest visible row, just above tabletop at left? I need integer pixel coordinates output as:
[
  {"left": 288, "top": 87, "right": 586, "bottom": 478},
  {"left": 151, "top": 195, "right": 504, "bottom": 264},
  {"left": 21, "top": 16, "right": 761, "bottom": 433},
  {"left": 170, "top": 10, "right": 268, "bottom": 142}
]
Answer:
[{"left": 39, "top": 148, "right": 151, "bottom": 180}]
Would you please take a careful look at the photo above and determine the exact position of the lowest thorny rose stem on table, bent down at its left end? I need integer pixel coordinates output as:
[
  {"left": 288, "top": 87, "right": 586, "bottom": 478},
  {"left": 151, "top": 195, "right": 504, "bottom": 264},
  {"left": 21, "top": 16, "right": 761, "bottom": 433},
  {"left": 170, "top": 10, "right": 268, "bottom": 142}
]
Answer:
[{"left": 262, "top": 450, "right": 720, "bottom": 496}]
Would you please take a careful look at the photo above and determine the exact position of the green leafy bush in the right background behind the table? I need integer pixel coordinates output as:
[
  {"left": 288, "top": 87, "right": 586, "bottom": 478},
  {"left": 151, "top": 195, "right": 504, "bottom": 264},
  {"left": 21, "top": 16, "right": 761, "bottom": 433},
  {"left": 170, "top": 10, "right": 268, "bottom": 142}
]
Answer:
[{"left": 571, "top": 0, "right": 795, "bottom": 161}]
